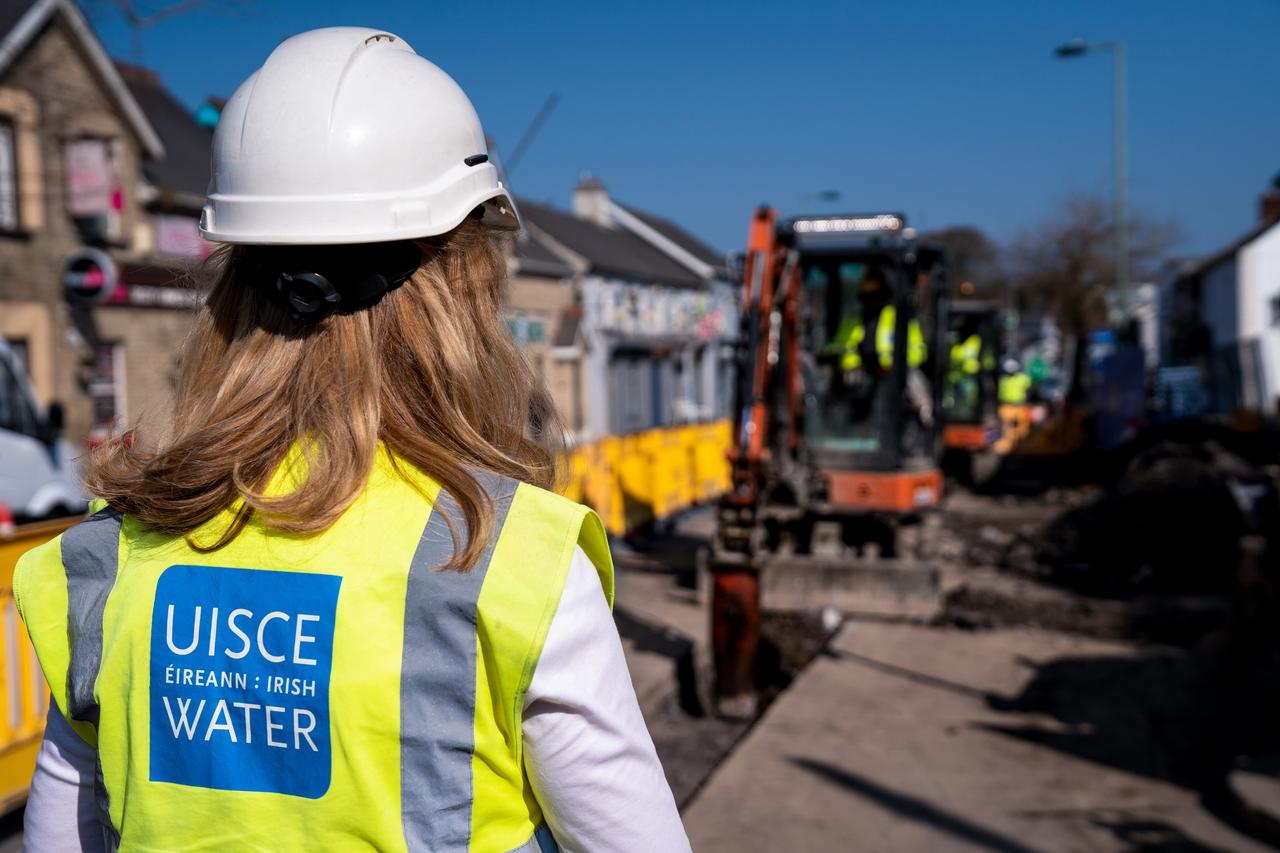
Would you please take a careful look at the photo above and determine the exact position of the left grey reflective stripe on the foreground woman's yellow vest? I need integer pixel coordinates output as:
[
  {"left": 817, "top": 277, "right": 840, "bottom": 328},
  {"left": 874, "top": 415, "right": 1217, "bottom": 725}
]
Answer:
[{"left": 61, "top": 507, "right": 123, "bottom": 849}]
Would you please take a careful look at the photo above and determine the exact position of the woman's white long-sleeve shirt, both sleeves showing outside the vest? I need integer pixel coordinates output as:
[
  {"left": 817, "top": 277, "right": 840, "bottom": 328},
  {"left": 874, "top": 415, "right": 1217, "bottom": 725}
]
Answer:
[{"left": 24, "top": 549, "right": 689, "bottom": 853}]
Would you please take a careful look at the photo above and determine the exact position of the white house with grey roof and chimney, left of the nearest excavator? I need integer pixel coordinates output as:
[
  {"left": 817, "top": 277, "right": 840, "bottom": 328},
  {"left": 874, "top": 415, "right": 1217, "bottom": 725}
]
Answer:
[{"left": 518, "top": 178, "right": 739, "bottom": 441}]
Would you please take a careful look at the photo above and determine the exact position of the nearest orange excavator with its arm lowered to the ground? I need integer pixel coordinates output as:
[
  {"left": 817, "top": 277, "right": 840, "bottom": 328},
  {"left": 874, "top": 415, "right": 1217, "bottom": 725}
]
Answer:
[{"left": 712, "top": 207, "right": 947, "bottom": 716}]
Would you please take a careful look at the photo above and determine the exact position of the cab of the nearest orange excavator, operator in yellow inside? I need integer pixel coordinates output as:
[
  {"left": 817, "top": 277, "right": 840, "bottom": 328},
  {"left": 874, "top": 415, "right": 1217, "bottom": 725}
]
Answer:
[{"left": 782, "top": 222, "right": 946, "bottom": 514}]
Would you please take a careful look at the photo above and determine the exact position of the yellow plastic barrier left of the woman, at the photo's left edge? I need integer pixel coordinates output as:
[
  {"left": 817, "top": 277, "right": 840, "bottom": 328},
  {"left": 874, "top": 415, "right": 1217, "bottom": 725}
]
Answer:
[{"left": 0, "top": 519, "right": 79, "bottom": 813}]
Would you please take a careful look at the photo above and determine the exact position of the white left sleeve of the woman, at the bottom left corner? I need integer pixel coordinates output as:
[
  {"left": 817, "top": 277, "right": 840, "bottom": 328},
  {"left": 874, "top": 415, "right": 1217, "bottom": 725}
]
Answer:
[{"left": 22, "top": 703, "right": 106, "bottom": 853}]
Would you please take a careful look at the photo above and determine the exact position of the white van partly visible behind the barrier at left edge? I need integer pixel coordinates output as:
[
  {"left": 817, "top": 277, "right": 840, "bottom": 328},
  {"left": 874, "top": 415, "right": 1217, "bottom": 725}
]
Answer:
[{"left": 0, "top": 338, "right": 87, "bottom": 523}]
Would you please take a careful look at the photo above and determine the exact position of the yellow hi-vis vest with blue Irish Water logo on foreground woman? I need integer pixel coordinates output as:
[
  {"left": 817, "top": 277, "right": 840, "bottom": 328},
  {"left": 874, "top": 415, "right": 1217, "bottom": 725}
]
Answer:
[{"left": 14, "top": 451, "right": 613, "bottom": 852}]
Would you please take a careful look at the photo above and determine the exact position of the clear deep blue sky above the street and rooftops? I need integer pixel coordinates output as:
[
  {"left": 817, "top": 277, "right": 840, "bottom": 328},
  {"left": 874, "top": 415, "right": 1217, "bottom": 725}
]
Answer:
[{"left": 93, "top": 0, "right": 1280, "bottom": 254}]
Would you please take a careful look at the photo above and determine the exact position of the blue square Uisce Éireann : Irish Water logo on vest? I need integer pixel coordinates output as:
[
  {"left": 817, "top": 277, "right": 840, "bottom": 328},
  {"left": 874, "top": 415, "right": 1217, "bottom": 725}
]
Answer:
[{"left": 151, "top": 565, "right": 342, "bottom": 799}]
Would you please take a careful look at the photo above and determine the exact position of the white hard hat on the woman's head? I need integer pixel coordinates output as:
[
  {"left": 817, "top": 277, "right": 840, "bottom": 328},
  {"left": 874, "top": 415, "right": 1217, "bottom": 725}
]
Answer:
[{"left": 200, "top": 27, "right": 518, "bottom": 245}]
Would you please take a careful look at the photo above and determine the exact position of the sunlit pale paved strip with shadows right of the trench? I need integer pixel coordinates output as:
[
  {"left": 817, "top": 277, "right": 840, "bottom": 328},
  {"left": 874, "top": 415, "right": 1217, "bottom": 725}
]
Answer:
[{"left": 685, "top": 624, "right": 1267, "bottom": 853}]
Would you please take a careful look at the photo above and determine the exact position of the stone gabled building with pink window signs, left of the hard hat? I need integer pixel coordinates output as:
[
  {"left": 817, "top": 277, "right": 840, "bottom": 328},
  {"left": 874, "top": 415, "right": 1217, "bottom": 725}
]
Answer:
[{"left": 0, "top": 0, "right": 210, "bottom": 444}]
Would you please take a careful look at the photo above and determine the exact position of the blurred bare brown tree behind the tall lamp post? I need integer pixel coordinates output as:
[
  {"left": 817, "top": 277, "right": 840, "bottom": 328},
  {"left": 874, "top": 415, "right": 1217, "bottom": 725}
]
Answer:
[{"left": 1009, "top": 190, "right": 1180, "bottom": 393}]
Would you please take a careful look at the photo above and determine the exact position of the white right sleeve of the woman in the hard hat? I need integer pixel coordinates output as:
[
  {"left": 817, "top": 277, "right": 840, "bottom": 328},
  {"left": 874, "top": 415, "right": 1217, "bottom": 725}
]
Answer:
[{"left": 522, "top": 548, "right": 689, "bottom": 853}]
